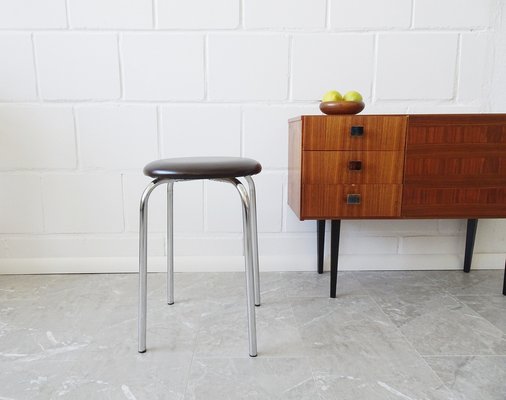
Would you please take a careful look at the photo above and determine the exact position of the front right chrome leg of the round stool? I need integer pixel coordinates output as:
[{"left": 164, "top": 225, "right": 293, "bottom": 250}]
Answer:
[{"left": 225, "top": 178, "right": 257, "bottom": 357}]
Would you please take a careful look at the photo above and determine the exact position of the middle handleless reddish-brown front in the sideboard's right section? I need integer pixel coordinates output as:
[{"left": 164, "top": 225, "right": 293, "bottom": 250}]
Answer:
[{"left": 404, "top": 151, "right": 506, "bottom": 187}]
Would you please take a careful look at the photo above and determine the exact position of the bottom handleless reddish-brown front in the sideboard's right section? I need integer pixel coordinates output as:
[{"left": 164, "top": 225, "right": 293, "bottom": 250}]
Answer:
[{"left": 402, "top": 185, "right": 506, "bottom": 218}]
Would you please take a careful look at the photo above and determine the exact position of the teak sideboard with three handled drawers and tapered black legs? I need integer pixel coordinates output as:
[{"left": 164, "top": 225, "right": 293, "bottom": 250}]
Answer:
[{"left": 288, "top": 114, "right": 506, "bottom": 297}]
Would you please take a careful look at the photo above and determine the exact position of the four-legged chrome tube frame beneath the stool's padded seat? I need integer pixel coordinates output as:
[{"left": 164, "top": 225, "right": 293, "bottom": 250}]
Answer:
[{"left": 138, "top": 176, "right": 260, "bottom": 357}]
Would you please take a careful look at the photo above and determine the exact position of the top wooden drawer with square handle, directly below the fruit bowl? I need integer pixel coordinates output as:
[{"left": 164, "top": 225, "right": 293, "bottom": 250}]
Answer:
[{"left": 300, "top": 115, "right": 407, "bottom": 150}]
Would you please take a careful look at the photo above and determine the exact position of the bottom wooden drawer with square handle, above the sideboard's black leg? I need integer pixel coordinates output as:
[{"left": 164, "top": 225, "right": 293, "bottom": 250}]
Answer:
[{"left": 301, "top": 184, "right": 401, "bottom": 219}]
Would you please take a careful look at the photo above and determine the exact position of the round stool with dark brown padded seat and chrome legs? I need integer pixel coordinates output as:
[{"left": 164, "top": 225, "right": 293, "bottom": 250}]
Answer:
[{"left": 139, "top": 157, "right": 262, "bottom": 357}]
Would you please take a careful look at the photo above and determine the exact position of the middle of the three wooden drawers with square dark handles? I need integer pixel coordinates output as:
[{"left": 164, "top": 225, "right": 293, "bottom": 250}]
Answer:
[{"left": 302, "top": 151, "right": 404, "bottom": 184}]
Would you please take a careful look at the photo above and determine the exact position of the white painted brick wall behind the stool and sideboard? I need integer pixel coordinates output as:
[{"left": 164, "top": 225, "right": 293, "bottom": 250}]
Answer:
[{"left": 0, "top": 0, "right": 506, "bottom": 273}]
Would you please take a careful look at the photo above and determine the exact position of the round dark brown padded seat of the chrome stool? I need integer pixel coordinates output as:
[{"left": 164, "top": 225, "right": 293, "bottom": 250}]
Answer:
[{"left": 144, "top": 157, "right": 262, "bottom": 179}]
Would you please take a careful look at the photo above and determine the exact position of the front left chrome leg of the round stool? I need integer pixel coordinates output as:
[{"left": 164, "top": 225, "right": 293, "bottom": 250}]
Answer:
[{"left": 138, "top": 180, "right": 163, "bottom": 353}]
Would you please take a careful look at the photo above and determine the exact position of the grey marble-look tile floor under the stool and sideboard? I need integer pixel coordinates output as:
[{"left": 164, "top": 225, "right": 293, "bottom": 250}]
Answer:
[{"left": 0, "top": 271, "right": 506, "bottom": 400}]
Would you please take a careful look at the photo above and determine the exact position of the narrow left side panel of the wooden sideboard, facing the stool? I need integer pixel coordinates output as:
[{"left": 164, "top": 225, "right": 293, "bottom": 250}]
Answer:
[{"left": 288, "top": 120, "right": 302, "bottom": 219}]
